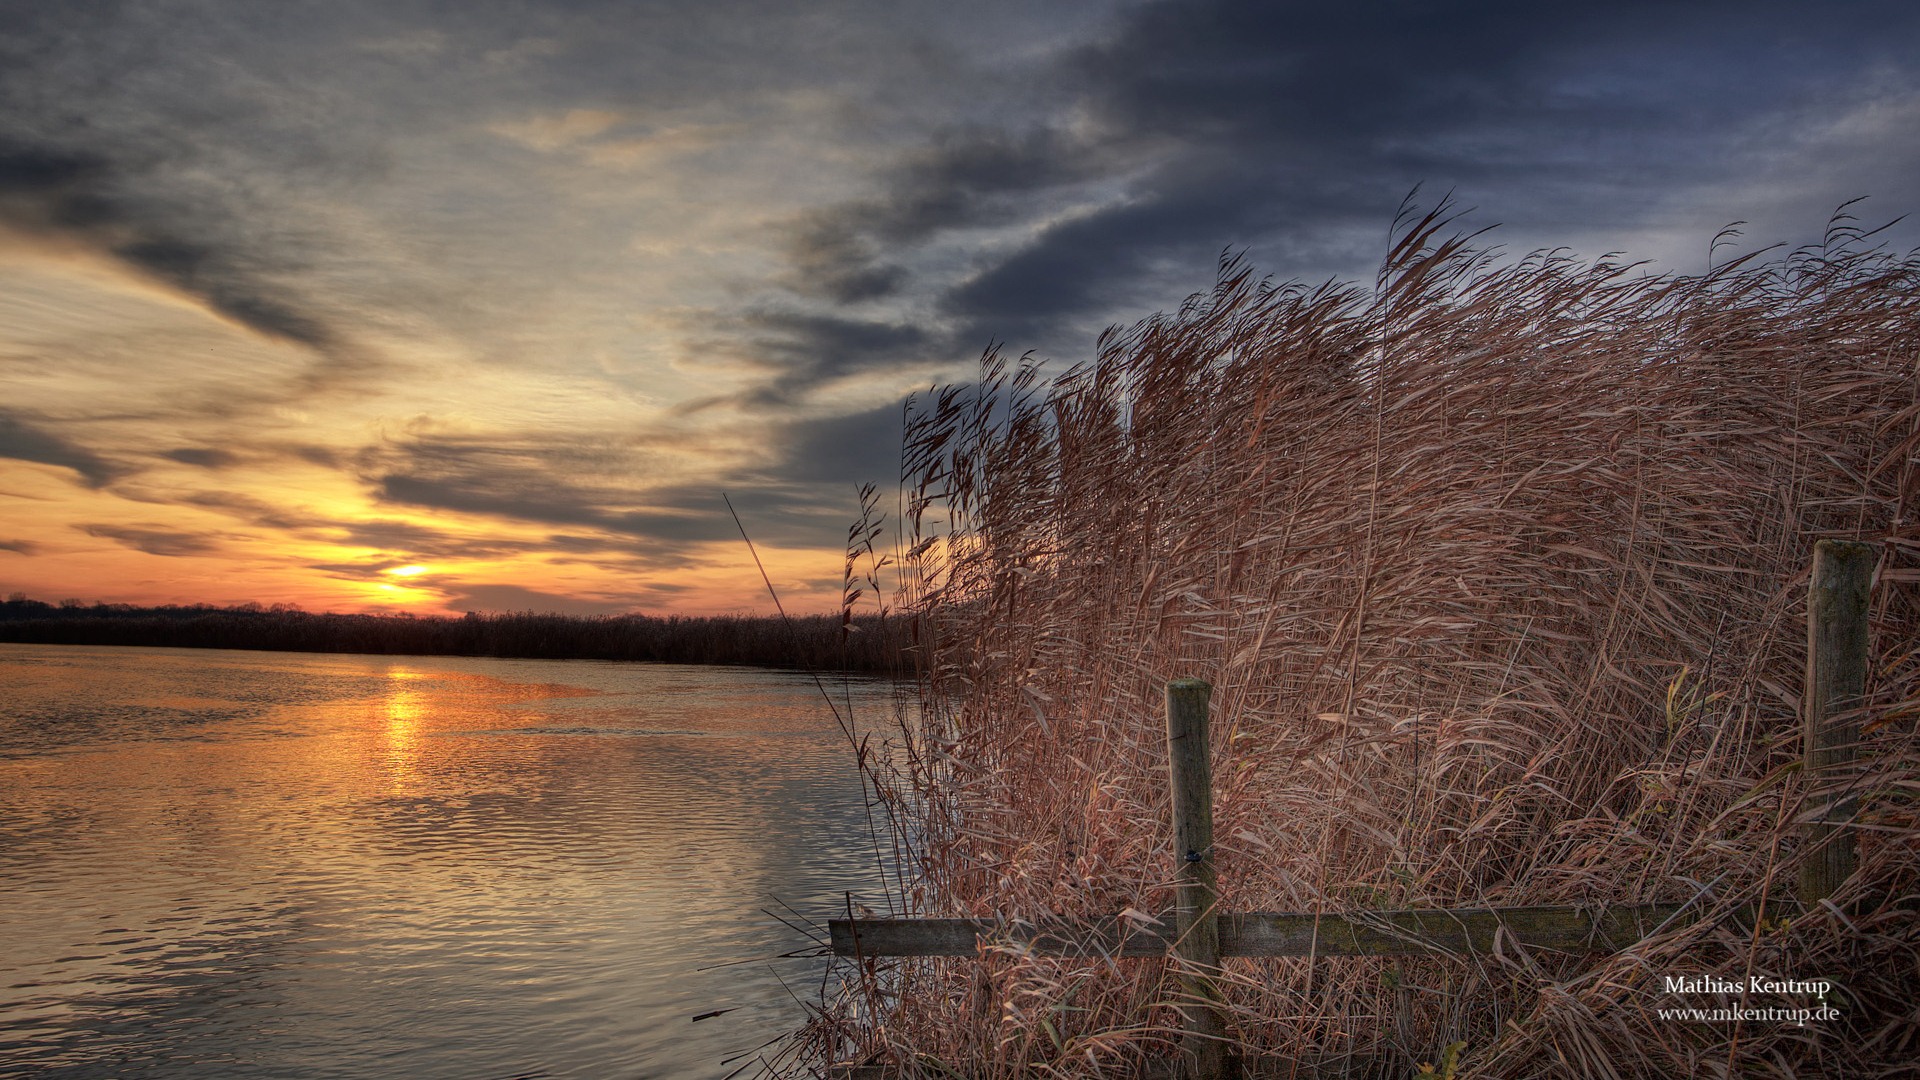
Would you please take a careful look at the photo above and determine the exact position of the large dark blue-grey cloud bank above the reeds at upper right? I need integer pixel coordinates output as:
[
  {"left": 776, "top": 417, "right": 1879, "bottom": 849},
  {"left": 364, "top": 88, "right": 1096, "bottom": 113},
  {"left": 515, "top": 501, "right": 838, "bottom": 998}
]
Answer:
[{"left": 789, "top": 0, "right": 1920, "bottom": 352}]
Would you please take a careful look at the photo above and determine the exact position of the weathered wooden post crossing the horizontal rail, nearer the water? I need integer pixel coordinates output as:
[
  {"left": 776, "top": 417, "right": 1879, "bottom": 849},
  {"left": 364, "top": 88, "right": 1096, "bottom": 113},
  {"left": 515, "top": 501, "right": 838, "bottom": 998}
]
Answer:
[{"left": 1167, "top": 678, "right": 1227, "bottom": 1080}]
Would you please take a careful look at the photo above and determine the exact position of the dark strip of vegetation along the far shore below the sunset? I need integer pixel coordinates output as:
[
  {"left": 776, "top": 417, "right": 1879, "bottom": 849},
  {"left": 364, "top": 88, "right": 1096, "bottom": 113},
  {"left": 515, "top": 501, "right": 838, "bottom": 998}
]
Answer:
[{"left": 0, "top": 594, "right": 912, "bottom": 675}]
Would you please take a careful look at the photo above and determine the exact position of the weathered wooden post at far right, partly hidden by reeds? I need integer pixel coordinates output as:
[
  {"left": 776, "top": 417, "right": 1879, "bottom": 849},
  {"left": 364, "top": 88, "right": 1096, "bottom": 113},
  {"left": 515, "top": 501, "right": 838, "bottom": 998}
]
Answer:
[{"left": 1799, "top": 540, "right": 1878, "bottom": 903}]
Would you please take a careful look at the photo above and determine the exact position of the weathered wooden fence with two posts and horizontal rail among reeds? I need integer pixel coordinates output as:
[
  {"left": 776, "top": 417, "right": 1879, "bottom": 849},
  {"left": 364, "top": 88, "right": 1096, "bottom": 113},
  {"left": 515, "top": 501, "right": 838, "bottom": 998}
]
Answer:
[{"left": 828, "top": 540, "right": 1876, "bottom": 1080}]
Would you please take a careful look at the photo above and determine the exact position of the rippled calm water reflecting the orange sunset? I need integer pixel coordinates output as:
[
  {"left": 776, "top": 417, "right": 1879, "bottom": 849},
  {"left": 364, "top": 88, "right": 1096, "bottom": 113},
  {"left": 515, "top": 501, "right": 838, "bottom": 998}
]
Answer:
[{"left": 0, "top": 644, "right": 891, "bottom": 1078}]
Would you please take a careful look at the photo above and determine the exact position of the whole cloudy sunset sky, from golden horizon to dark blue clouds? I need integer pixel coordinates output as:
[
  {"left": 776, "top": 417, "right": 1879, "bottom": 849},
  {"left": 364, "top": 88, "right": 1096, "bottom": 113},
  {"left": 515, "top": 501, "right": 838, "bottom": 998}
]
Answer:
[{"left": 0, "top": 0, "right": 1920, "bottom": 615}]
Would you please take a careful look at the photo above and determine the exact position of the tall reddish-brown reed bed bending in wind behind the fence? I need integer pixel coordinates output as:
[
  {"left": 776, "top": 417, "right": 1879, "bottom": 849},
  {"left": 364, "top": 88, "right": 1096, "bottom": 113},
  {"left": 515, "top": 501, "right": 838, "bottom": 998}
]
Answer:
[{"left": 781, "top": 209, "right": 1920, "bottom": 1078}]
